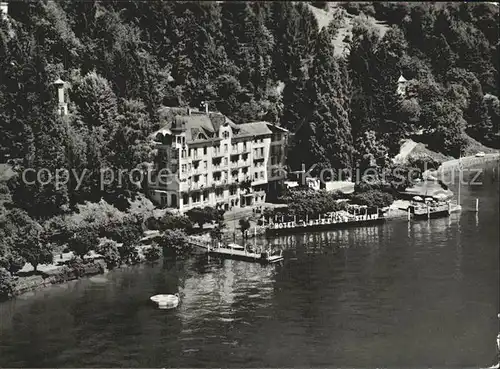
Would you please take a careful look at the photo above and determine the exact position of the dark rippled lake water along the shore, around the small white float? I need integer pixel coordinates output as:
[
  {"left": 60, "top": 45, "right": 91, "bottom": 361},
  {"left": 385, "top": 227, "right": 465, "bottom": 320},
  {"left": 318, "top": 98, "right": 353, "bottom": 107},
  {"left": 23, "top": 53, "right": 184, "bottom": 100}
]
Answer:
[{"left": 0, "top": 162, "right": 499, "bottom": 368}]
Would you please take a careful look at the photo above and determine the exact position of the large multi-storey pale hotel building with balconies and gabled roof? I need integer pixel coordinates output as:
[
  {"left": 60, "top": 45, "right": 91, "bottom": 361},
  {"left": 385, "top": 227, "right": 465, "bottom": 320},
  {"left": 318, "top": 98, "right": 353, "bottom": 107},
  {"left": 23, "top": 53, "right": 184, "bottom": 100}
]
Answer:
[{"left": 148, "top": 109, "right": 289, "bottom": 212}]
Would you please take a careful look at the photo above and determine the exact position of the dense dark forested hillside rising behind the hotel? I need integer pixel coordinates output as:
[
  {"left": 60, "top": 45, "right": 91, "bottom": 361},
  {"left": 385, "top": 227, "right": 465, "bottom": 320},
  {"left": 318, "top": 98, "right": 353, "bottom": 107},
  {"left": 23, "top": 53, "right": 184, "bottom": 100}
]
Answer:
[{"left": 0, "top": 0, "right": 500, "bottom": 216}]
